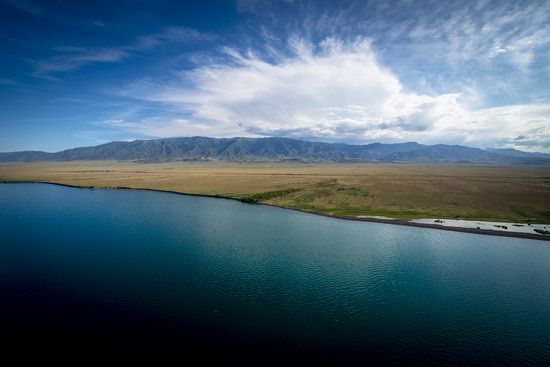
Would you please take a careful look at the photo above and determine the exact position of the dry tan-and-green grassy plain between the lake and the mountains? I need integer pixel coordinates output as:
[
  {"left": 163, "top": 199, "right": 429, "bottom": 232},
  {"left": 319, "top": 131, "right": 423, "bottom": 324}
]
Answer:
[{"left": 0, "top": 162, "right": 550, "bottom": 223}]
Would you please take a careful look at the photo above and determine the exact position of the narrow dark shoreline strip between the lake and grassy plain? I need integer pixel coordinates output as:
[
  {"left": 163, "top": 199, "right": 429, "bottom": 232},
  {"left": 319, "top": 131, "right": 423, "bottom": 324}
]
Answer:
[{"left": 4, "top": 180, "right": 550, "bottom": 241}]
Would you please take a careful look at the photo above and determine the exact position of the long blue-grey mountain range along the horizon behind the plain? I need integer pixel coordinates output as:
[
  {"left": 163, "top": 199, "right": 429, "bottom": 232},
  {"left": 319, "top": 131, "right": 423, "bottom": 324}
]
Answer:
[{"left": 0, "top": 137, "right": 550, "bottom": 164}]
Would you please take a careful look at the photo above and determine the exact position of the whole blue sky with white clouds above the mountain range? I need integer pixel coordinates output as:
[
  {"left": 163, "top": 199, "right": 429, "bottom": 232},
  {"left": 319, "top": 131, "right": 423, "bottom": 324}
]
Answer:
[{"left": 0, "top": 0, "right": 550, "bottom": 153}]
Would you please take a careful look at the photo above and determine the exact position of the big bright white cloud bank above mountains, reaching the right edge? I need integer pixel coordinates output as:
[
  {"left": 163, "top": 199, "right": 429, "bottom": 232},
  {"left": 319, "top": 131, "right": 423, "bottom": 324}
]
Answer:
[{"left": 112, "top": 37, "right": 550, "bottom": 150}]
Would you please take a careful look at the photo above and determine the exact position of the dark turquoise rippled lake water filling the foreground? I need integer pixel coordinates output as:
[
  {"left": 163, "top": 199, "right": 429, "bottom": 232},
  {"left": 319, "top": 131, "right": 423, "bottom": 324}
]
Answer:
[{"left": 0, "top": 184, "right": 550, "bottom": 365}]
